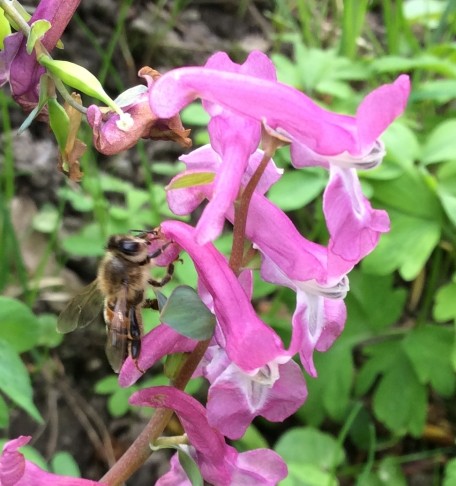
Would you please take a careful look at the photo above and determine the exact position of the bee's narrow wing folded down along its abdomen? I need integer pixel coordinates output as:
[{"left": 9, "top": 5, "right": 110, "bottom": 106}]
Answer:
[{"left": 106, "top": 289, "right": 130, "bottom": 373}]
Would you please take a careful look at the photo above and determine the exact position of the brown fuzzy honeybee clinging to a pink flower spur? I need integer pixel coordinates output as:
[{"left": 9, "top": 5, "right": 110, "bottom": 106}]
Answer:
[{"left": 57, "top": 230, "right": 174, "bottom": 373}]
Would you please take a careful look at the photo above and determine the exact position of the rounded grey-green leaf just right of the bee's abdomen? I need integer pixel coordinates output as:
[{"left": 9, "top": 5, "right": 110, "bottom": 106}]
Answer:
[{"left": 160, "top": 285, "right": 215, "bottom": 340}]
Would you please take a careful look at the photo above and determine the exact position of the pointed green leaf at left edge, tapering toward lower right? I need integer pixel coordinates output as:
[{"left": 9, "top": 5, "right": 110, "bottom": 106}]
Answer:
[{"left": 0, "top": 340, "right": 43, "bottom": 424}]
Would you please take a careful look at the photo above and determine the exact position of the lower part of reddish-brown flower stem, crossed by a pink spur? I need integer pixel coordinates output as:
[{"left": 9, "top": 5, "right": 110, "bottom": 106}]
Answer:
[{"left": 100, "top": 340, "right": 210, "bottom": 486}]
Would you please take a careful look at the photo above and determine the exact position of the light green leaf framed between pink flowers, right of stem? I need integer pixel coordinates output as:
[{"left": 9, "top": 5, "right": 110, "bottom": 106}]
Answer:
[{"left": 268, "top": 168, "right": 327, "bottom": 211}]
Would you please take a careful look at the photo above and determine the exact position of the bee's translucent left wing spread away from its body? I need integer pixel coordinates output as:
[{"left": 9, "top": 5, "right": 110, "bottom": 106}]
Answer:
[{"left": 57, "top": 280, "right": 104, "bottom": 333}]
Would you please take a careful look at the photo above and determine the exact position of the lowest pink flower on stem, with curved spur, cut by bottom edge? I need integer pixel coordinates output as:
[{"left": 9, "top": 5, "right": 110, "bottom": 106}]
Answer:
[{"left": 130, "top": 386, "right": 287, "bottom": 486}]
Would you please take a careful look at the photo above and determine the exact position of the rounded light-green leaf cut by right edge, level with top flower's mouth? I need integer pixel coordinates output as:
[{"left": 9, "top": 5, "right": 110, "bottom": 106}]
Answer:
[{"left": 422, "top": 119, "right": 456, "bottom": 164}]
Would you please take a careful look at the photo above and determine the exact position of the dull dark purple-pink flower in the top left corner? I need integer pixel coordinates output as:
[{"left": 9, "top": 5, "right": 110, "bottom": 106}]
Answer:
[{"left": 0, "top": 0, "right": 80, "bottom": 112}]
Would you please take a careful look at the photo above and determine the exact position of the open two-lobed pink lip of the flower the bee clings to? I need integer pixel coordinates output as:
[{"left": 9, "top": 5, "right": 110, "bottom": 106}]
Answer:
[{"left": 202, "top": 346, "right": 307, "bottom": 439}]
